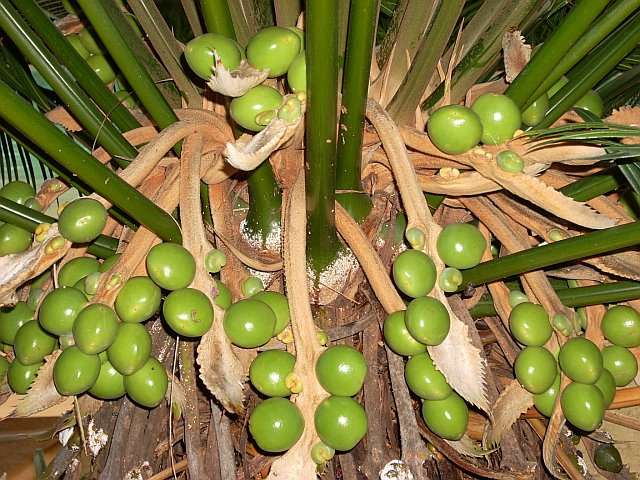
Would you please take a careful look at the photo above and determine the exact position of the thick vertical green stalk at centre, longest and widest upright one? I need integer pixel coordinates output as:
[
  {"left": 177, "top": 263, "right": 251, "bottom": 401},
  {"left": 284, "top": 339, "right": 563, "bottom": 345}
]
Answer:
[{"left": 306, "top": 0, "right": 339, "bottom": 272}]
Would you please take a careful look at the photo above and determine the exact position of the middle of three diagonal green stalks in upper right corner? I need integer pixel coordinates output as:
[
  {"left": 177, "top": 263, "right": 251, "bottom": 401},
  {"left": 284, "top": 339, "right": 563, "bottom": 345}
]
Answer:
[{"left": 525, "top": 0, "right": 640, "bottom": 106}]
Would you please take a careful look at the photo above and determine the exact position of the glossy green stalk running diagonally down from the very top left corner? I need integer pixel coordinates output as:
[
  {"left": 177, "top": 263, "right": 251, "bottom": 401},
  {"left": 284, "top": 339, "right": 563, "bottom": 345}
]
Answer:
[{"left": 0, "top": 0, "right": 138, "bottom": 163}]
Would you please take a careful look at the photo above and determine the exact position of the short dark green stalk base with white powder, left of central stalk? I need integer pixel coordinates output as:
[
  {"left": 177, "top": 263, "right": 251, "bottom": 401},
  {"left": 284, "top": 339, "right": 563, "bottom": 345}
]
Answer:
[{"left": 245, "top": 161, "right": 282, "bottom": 246}]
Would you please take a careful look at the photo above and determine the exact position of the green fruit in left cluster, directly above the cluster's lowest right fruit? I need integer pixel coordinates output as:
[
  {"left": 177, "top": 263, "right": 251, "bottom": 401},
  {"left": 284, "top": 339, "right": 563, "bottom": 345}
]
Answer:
[{"left": 107, "top": 323, "right": 151, "bottom": 375}]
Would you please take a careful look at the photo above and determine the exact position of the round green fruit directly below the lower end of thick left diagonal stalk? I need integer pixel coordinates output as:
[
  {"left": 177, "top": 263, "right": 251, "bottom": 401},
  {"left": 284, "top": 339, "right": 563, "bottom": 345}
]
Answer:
[{"left": 147, "top": 243, "right": 196, "bottom": 290}]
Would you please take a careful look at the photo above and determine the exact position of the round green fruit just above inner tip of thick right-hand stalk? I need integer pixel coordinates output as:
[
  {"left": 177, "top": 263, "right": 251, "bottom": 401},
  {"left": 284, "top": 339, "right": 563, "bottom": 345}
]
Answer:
[{"left": 436, "top": 223, "right": 487, "bottom": 269}]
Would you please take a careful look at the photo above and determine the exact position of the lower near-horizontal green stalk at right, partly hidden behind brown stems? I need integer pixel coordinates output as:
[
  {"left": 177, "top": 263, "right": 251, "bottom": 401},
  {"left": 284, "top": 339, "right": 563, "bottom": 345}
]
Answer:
[{"left": 469, "top": 281, "right": 640, "bottom": 318}]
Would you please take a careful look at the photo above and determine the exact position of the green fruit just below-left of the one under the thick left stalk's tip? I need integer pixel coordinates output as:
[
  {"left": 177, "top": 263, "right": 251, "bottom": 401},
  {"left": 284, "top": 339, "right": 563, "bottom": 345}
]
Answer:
[{"left": 114, "top": 277, "right": 162, "bottom": 323}]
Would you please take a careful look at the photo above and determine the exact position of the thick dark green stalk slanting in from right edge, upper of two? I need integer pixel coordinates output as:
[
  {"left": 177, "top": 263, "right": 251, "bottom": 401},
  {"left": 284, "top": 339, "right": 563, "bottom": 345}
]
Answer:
[{"left": 460, "top": 222, "right": 640, "bottom": 290}]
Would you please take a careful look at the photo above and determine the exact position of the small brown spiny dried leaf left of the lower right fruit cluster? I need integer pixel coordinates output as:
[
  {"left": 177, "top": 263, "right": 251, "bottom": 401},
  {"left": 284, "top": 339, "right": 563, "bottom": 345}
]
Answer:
[{"left": 483, "top": 379, "right": 533, "bottom": 447}]
